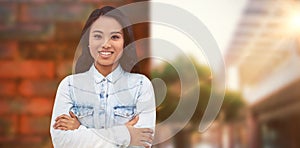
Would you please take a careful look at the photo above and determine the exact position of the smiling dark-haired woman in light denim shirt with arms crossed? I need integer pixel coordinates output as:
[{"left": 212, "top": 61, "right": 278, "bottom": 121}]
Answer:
[{"left": 50, "top": 6, "right": 155, "bottom": 147}]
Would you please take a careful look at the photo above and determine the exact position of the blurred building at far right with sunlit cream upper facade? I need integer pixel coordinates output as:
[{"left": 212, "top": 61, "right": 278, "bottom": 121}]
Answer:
[{"left": 225, "top": 0, "right": 300, "bottom": 148}]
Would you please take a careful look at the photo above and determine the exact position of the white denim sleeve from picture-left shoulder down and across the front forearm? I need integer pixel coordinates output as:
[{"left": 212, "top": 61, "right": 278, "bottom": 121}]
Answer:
[{"left": 50, "top": 76, "right": 130, "bottom": 148}]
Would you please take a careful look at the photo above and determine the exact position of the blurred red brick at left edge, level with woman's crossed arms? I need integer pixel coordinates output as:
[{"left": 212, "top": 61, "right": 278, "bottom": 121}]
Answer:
[{"left": 0, "top": 114, "right": 18, "bottom": 137}]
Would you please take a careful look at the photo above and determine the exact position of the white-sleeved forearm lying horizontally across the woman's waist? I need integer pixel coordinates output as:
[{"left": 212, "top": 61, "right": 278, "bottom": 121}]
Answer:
[{"left": 51, "top": 126, "right": 130, "bottom": 148}]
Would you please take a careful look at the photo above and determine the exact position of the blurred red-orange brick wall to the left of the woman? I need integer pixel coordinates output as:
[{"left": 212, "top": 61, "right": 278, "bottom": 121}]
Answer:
[{"left": 0, "top": 0, "right": 149, "bottom": 147}]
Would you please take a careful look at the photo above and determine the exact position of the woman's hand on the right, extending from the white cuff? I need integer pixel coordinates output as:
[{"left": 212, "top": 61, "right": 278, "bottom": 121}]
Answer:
[{"left": 126, "top": 124, "right": 153, "bottom": 147}]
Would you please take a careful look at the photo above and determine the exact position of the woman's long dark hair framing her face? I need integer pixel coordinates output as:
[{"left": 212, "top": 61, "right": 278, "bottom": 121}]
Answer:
[{"left": 75, "top": 6, "right": 140, "bottom": 73}]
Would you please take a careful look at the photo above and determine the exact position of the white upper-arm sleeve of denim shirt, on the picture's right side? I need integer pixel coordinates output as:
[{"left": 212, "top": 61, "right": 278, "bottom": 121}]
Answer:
[{"left": 135, "top": 76, "right": 156, "bottom": 130}]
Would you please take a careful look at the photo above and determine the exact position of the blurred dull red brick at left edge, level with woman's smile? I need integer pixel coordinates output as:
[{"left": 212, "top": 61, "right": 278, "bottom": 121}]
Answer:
[{"left": 0, "top": 41, "right": 18, "bottom": 59}]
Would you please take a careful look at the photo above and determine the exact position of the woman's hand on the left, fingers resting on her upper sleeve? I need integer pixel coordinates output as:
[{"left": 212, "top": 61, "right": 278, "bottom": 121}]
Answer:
[{"left": 53, "top": 111, "right": 80, "bottom": 131}]
